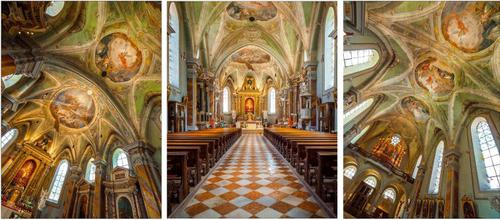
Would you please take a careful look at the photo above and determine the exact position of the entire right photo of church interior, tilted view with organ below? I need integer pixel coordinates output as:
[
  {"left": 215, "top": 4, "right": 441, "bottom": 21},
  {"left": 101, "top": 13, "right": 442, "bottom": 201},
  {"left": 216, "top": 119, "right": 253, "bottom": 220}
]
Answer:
[{"left": 343, "top": 1, "right": 500, "bottom": 218}]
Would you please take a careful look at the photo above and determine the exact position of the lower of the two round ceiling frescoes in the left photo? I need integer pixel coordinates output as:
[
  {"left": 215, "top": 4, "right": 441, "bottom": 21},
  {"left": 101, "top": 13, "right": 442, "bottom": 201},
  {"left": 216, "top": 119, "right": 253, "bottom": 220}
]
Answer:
[{"left": 50, "top": 88, "right": 95, "bottom": 128}]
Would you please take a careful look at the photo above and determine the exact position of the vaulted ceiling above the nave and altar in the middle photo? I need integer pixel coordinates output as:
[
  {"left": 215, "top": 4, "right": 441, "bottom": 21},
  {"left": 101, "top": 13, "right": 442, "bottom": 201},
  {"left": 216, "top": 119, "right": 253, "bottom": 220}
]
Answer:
[{"left": 178, "top": 2, "right": 325, "bottom": 88}]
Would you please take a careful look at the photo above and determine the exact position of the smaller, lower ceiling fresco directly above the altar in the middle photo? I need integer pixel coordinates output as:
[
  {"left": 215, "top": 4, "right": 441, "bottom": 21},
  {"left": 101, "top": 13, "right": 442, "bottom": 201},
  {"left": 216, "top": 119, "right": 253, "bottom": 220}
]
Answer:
[{"left": 231, "top": 47, "right": 271, "bottom": 71}]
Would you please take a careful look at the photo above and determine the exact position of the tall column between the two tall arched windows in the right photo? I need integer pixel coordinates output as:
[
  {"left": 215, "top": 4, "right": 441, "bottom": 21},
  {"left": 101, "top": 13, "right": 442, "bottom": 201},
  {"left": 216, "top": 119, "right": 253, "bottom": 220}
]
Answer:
[{"left": 444, "top": 149, "right": 460, "bottom": 218}]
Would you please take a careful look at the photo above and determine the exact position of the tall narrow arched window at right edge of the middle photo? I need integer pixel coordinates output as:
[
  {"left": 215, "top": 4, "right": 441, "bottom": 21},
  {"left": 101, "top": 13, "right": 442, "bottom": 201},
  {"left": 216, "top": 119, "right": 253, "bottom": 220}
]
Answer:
[{"left": 324, "top": 7, "right": 335, "bottom": 90}]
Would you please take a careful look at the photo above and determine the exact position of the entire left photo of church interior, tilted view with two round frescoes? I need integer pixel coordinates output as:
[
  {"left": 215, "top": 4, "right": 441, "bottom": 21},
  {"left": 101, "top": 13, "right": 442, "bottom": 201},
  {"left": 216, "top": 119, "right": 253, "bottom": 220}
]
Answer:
[{"left": 1, "top": 1, "right": 162, "bottom": 219}]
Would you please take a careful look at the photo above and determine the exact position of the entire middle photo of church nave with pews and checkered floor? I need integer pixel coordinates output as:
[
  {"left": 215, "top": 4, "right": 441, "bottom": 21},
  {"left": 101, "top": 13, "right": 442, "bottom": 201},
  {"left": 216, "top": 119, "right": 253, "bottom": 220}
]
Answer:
[{"left": 166, "top": 2, "right": 337, "bottom": 218}]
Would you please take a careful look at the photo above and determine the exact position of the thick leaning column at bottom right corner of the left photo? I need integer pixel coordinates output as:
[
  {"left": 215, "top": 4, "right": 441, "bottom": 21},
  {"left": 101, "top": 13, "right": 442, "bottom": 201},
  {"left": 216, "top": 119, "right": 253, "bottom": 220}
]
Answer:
[{"left": 125, "top": 141, "right": 161, "bottom": 218}]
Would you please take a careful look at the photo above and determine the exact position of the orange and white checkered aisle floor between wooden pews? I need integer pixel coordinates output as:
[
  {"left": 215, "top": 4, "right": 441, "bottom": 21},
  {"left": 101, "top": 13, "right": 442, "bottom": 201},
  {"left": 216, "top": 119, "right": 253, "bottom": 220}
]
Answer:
[{"left": 172, "top": 134, "right": 326, "bottom": 218}]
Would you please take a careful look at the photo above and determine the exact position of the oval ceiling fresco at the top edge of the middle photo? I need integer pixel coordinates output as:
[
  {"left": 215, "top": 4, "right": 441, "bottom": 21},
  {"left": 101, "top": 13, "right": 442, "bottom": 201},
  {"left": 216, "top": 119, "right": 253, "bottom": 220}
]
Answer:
[{"left": 226, "top": 2, "right": 278, "bottom": 21}]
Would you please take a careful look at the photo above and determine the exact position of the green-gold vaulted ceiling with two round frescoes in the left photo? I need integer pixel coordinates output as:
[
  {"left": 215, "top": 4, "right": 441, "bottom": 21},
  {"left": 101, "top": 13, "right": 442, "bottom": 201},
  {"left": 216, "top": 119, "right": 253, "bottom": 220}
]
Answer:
[{"left": 2, "top": 2, "right": 161, "bottom": 163}]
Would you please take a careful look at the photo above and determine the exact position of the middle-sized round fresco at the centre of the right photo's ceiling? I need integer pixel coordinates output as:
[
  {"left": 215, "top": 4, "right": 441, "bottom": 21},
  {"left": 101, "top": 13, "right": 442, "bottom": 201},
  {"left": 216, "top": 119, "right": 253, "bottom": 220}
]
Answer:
[{"left": 415, "top": 58, "right": 455, "bottom": 96}]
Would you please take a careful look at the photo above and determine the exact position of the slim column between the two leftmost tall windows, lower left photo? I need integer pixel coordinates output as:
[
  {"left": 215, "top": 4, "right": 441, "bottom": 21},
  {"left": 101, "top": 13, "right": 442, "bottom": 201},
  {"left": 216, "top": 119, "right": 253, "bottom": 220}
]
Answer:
[{"left": 63, "top": 166, "right": 82, "bottom": 218}]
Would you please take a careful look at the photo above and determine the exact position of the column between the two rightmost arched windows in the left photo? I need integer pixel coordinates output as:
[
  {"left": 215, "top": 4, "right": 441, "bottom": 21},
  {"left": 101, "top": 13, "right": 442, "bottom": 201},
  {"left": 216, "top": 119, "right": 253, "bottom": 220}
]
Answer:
[{"left": 92, "top": 158, "right": 106, "bottom": 218}]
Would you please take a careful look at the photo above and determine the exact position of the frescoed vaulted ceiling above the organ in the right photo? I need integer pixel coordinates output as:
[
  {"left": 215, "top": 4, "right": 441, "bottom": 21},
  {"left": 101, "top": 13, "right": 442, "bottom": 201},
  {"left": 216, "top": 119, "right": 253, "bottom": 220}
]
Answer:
[{"left": 345, "top": 2, "right": 500, "bottom": 167}]
